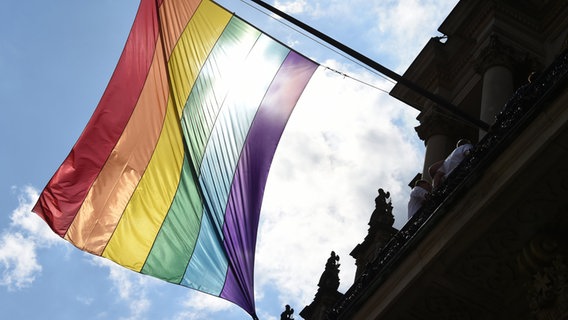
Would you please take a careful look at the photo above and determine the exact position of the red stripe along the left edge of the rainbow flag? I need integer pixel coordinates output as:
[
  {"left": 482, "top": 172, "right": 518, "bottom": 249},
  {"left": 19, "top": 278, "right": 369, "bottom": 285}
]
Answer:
[{"left": 33, "top": 0, "right": 162, "bottom": 237}]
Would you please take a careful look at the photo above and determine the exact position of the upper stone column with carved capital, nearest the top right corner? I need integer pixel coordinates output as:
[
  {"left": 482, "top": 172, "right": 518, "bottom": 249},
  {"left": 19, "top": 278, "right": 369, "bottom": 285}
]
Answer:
[{"left": 478, "top": 35, "right": 514, "bottom": 139}]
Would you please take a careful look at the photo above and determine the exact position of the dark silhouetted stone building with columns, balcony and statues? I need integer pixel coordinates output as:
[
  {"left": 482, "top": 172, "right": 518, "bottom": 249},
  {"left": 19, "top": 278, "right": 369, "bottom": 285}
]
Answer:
[{"left": 300, "top": 0, "right": 568, "bottom": 320}]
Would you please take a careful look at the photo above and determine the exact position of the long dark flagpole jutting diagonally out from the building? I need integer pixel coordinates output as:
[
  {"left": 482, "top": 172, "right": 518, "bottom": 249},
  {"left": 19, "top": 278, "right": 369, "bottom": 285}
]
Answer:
[{"left": 250, "top": 0, "right": 490, "bottom": 131}]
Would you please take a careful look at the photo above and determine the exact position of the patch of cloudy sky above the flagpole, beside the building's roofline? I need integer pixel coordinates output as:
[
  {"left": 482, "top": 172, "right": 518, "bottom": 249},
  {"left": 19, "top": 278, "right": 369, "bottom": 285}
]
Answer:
[{"left": 275, "top": 0, "right": 458, "bottom": 71}]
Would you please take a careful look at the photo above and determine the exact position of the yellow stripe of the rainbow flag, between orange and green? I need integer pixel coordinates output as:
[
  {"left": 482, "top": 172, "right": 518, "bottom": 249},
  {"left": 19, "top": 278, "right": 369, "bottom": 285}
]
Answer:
[{"left": 102, "top": 1, "right": 231, "bottom": 272}]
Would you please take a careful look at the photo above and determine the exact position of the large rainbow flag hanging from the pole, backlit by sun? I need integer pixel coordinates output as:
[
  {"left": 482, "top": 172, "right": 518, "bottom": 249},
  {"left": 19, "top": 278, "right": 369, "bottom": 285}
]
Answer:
[{"left": 33, "top": 0, "right": 318, "bottom": 317}]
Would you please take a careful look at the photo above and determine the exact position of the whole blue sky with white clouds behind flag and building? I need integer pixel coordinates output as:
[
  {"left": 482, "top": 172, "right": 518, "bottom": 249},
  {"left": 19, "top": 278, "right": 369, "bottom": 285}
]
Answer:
[{"left": 0, "top": 0, "right": 457, "bottom": 320}]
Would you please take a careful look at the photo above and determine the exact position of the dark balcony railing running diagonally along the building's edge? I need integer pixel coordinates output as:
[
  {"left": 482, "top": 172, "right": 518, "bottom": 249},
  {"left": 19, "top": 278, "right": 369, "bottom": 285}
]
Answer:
[{"left": 328, "top": 50, "right": 568, "bottom": 320}]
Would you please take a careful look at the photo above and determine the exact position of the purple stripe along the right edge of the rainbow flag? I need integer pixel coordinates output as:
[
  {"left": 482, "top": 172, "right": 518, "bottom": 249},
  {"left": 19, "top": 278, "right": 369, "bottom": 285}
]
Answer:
[{"left": 220, "top": 51, "right": 317, "bottom": 314}]
